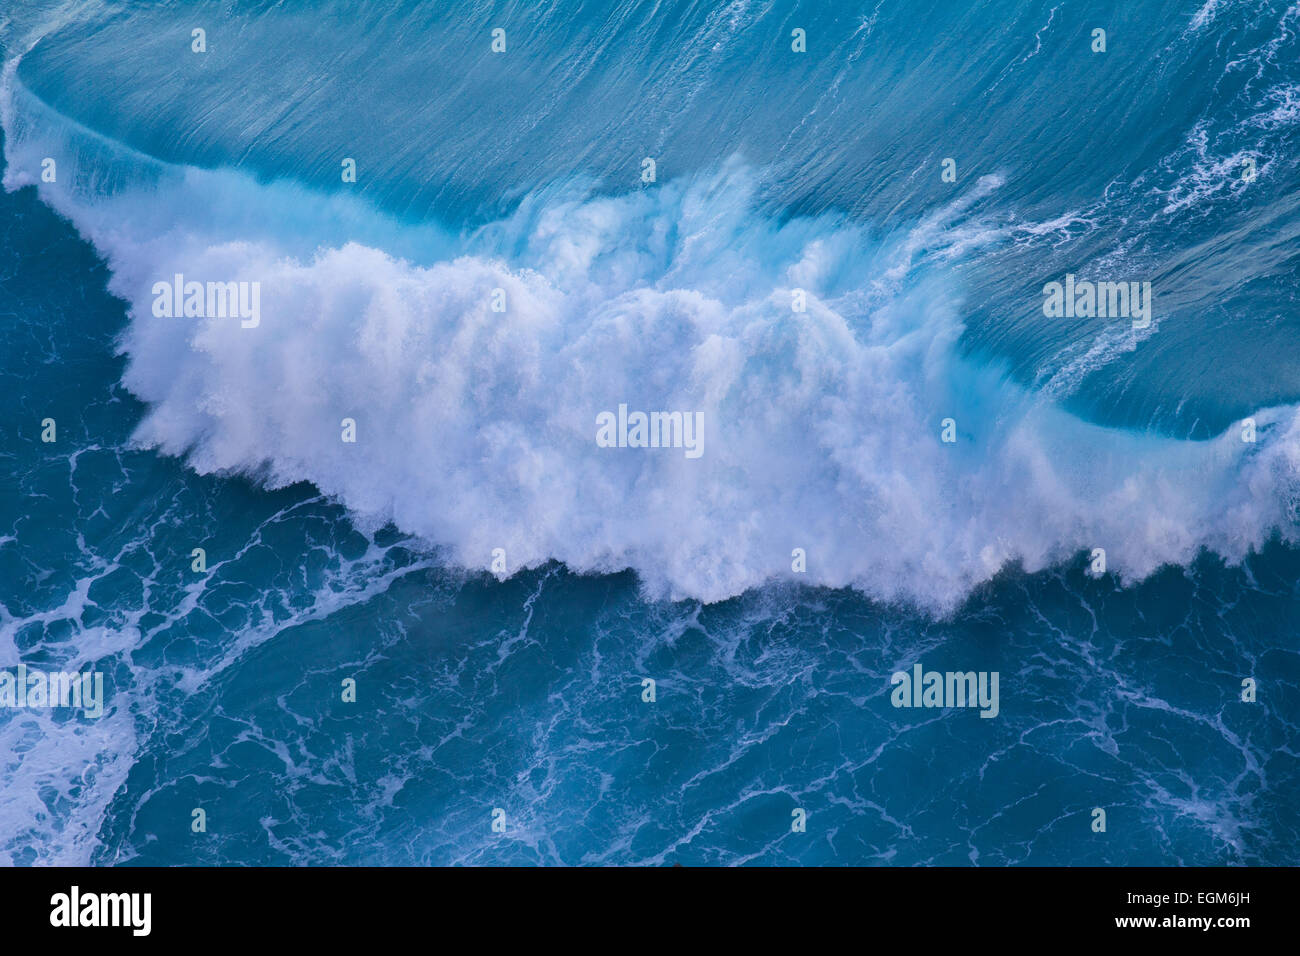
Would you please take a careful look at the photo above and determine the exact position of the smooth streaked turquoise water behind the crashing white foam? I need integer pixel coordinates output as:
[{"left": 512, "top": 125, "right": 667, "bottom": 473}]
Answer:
[{"left": 10, "top": 0, "right": 1300, "bottom": 429}]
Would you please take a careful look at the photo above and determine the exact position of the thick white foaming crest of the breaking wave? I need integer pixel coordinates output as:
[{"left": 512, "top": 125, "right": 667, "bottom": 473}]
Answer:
[{"left": 3, "top": 66, "right": 1300, "bottom": 609}]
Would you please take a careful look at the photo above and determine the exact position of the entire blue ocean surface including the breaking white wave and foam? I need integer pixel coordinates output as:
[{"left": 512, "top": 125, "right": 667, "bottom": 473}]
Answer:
[{"left": 0, "top": 0, "right": 1300, "bottom": 865}]
